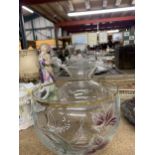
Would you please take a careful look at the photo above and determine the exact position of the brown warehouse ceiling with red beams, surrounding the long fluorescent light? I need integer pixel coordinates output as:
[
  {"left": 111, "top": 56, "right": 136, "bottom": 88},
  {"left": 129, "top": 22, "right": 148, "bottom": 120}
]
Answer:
[{"left": 22, "top": 0, "right": 135, "bottom": 30}]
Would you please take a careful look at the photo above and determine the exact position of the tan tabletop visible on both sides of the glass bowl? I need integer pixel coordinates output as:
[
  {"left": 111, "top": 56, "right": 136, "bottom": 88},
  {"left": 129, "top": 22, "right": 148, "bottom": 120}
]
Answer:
[{"left": 19, "top": 117, "right": 135, "bottom": 155}]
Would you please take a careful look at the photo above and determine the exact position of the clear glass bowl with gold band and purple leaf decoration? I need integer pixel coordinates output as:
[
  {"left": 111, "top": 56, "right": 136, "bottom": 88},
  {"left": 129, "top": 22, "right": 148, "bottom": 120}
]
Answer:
[{"left": 32, "top": 59, "right": 120, "bottom": 155}]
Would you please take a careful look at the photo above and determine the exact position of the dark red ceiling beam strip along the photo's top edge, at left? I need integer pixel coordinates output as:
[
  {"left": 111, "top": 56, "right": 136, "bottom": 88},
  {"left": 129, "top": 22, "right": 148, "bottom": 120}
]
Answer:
[{"left": 20, "top": 0, "right": 67, "bottom": 5}]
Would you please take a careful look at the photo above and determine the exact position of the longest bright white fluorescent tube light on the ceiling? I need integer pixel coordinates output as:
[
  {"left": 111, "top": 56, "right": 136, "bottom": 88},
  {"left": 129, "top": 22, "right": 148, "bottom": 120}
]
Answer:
[{"left": 68, "top": 6, "right": 135, "bottom": 17}]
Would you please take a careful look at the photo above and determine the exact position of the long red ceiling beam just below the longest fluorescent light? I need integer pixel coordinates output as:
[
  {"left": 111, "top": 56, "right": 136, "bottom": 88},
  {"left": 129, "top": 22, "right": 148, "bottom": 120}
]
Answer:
[{"left": 57, "top": 16, "right": 135, "bottom": 27}]
